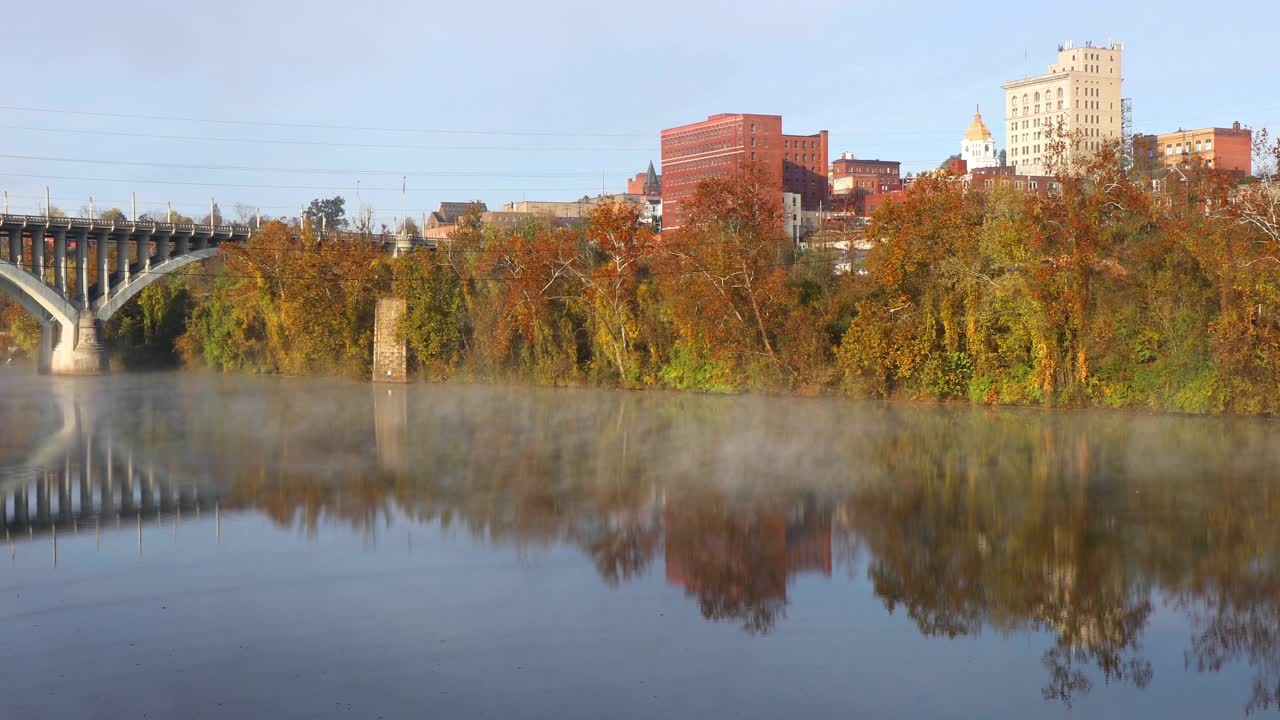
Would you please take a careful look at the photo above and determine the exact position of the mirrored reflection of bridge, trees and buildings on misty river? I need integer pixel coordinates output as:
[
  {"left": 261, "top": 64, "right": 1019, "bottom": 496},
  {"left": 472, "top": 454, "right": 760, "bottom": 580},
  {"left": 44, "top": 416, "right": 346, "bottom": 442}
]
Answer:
[{"left": 0, "top": 375, "right": 1280, "bottom": 712}]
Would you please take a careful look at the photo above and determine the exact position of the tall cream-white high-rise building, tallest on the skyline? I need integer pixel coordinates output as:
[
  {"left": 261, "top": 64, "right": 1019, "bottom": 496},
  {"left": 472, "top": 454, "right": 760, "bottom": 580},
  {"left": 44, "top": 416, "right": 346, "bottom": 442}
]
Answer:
[{"left": 1004, "top": 42, "right": 1124, "bottom": 176}]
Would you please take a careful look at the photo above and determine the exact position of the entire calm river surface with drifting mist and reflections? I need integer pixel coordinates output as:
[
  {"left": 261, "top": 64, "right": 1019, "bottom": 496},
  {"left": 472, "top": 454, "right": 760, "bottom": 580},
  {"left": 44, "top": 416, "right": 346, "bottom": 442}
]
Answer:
[{"left": 0, "top": 370, "right": 1280, "bottom": 719}]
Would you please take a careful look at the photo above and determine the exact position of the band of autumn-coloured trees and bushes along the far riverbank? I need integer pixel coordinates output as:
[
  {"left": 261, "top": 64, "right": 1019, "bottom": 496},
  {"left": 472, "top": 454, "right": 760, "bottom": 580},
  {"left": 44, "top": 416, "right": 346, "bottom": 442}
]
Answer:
[{"left": 5, "top": 132, "right": 1280, "bottom": 414}]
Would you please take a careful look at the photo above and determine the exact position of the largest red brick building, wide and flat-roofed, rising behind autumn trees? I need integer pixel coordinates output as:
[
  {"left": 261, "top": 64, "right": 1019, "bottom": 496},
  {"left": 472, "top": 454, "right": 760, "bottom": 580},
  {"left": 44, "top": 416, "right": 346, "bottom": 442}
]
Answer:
[{"left": 662, "top": 113, "right": 828, "bottom": 229}]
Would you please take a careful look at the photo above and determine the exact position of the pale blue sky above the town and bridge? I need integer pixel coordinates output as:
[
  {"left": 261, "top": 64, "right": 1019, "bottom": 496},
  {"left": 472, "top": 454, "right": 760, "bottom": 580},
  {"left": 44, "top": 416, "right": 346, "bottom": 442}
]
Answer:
[{"left": 0, "top": 0, "right": 1280, "bottom": 224}]
